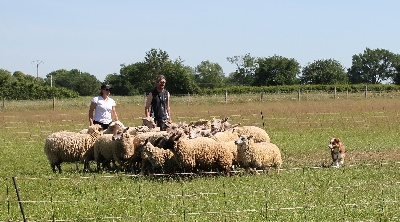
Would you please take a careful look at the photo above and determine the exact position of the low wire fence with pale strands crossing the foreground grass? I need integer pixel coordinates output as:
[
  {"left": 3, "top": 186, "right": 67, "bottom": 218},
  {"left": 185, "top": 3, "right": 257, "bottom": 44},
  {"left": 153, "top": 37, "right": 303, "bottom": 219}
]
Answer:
[{"left": 0, "top": 162, "right": 400, "bottom": 221}]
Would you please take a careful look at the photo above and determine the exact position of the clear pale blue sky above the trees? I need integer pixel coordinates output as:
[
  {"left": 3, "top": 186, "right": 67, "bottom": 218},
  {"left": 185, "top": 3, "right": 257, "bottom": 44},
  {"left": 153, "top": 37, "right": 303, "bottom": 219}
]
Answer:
[{"left": 0, "top": 0, "right": 400, "bottom": 81}]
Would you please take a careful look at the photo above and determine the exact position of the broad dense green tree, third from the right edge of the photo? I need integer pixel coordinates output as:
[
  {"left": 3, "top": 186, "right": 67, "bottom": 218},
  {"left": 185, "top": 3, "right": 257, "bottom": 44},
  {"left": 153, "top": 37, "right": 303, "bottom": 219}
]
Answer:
[{"left": 252, "top": 55, "right": 300, "bottom": 86}]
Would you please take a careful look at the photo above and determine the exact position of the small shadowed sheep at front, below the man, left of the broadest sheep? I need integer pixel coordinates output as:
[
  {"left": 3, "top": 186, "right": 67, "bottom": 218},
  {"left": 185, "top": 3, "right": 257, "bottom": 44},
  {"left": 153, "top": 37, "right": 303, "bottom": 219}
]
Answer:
[{"left": 141, "top": 140, "right": 179, "bottom": 174}]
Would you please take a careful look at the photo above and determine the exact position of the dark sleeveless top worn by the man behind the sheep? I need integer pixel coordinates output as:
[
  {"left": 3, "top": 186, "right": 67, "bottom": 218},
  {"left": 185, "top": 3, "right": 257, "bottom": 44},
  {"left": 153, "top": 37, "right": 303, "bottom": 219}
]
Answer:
[{"left": 150, "top": 88, "right": 168, "bottom": 120}]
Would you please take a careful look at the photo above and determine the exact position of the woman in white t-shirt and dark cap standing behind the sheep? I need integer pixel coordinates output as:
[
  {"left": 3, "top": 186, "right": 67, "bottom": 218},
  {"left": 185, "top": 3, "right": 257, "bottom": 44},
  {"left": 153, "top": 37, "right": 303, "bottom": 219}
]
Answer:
[{"left": 89, "top": 84, "right": 118, "bottom": 129}]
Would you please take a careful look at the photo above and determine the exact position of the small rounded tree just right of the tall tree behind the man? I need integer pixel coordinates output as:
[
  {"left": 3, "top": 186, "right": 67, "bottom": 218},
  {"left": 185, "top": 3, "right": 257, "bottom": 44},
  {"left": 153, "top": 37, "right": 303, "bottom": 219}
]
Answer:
[{"left": 195, "top": 60, "right": 226, "bottom": 88}]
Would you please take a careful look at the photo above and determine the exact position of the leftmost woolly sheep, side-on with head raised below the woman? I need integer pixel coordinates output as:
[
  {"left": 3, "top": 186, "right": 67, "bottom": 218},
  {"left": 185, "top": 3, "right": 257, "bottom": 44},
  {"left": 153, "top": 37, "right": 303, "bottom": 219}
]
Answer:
[{"left": 44, "top": 124, "right": 103, "bottom": 173}]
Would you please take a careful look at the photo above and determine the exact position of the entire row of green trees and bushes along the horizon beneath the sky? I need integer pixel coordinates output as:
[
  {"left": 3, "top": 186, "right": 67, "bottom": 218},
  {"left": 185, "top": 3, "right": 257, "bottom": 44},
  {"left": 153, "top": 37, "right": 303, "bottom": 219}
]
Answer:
[{"left": 0, "top": 48, "right": 400, "bottom": 99}]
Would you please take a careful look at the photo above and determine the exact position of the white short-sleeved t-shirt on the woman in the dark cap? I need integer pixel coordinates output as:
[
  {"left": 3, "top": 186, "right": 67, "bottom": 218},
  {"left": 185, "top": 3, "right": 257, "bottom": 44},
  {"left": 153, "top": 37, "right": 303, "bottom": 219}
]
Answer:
[{"left": 92, "top": 96, "right": 116, "bottom": 124}]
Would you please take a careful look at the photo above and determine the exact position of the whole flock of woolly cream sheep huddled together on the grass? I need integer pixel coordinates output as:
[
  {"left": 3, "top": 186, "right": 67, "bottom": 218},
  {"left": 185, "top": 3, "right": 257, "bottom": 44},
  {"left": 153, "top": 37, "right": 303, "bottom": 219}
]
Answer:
[{"left": 44, "top": 118, "right": 282, "bottom": 175}]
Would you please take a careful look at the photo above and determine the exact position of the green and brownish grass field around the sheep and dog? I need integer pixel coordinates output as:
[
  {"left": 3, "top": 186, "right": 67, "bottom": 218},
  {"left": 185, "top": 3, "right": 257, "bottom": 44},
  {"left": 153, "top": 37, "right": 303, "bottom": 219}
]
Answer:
[{"left": 0, "top": 93, "right": 400, "bottom": 221}]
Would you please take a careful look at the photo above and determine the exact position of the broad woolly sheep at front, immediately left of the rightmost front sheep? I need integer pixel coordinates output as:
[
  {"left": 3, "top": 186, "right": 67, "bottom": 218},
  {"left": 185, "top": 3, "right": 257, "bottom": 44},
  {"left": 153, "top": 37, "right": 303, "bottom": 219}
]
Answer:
[{"left": 173, "top": 132, "right": 233, "bottom": 173}]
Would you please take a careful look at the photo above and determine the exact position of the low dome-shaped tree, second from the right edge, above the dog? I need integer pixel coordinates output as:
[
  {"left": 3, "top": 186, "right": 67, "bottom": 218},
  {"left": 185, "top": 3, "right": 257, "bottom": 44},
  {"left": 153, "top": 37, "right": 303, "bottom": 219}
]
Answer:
[{"left": 300, "top": 59, "right": 348, "bottom": 85}]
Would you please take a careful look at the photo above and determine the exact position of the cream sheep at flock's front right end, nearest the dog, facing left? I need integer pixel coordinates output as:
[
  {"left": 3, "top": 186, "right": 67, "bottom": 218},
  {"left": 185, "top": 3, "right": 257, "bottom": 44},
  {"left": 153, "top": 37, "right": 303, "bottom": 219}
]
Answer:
[{"left": 235, "top": 135, "right": 282, "bottom": 172}]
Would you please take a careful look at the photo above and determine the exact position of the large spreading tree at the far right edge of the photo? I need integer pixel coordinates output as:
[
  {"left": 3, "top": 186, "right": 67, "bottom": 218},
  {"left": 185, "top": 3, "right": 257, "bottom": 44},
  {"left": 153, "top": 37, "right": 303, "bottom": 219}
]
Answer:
[{"left": 348, "top": 48, "right": 398, "bottom": 84}]
